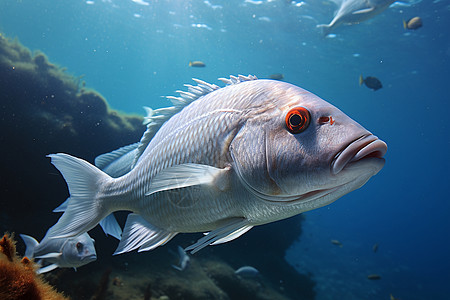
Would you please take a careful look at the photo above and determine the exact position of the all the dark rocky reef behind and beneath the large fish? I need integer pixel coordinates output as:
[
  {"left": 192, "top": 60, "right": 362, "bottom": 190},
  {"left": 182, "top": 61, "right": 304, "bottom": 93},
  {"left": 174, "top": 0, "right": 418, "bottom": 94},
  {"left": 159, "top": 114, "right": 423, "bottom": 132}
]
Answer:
[{"left": 0, "top": 35, "right": 315, "bottom": 299}]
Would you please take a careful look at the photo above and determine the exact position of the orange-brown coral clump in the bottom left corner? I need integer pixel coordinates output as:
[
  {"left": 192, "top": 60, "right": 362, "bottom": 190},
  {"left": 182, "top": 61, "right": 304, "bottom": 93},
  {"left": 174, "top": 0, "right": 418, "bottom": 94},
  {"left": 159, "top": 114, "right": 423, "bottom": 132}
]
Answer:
[{"left": 0, "top": 234, "right": 68, "bottom": 300}]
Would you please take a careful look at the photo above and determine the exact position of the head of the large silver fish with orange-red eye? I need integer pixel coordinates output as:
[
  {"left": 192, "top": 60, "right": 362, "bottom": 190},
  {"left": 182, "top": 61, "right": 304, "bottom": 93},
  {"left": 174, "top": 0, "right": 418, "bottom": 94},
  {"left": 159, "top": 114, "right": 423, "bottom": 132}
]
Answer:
[{"left": 231, "top": 80, "right": 387, "bottom": 213}]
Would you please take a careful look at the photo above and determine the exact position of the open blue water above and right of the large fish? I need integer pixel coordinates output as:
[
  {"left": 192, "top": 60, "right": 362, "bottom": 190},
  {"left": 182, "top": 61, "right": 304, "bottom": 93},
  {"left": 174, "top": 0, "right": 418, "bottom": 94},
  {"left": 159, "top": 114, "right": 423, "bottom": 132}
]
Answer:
[{"left": 0, "top": 0, "right": 450, "bottom": 299}]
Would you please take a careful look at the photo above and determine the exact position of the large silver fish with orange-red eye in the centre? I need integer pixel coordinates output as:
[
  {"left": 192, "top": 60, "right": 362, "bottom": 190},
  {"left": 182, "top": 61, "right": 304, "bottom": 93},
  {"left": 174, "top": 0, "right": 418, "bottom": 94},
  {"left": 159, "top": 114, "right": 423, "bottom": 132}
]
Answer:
[{"left": 49, "top": 75, "right": 387, "bottom": 254}]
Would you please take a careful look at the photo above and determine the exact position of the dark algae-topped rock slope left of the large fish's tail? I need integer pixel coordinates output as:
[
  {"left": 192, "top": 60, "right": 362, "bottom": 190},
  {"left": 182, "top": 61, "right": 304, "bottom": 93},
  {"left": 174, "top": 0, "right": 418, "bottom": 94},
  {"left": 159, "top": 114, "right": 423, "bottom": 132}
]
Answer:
[{"left": 0, "top": 35, "right": 145, "bottom": 236}]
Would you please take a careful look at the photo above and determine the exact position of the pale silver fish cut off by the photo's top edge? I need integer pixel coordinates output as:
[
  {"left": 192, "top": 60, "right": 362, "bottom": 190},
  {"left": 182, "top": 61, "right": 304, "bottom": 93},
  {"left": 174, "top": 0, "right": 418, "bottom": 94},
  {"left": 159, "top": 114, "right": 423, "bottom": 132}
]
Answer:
[{"left": 317, "top": 0, "right": 395, "bottom": 35}]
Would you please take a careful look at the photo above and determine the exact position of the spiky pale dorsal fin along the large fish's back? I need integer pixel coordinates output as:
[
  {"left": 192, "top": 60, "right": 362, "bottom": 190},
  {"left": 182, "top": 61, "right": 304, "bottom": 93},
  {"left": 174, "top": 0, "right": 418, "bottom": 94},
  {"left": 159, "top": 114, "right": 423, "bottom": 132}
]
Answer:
[{"left": 131, "top": 75, "right": 258, "bottom": 168}]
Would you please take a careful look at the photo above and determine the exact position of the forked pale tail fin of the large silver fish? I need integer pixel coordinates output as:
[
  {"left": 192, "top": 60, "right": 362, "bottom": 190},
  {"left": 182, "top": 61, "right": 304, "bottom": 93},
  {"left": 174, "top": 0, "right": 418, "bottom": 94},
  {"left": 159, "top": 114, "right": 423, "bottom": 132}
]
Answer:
[{"left": 46, "top": 153, "right": 111, "bottom": 238}]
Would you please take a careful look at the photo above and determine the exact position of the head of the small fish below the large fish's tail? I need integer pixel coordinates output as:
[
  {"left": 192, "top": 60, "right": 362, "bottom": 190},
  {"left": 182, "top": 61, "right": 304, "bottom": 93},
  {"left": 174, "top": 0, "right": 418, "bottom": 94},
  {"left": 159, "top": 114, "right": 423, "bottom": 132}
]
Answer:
[{"left": 62, "top": 233, "right": 97, "bottom": 267}]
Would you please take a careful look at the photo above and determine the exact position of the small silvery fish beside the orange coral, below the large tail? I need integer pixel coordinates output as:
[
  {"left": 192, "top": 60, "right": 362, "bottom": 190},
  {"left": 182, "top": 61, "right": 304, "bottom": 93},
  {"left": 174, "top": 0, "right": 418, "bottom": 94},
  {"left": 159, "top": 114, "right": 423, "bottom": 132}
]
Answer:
[{"left": 20, "top": 233, "right": 97, "bottom": 274}]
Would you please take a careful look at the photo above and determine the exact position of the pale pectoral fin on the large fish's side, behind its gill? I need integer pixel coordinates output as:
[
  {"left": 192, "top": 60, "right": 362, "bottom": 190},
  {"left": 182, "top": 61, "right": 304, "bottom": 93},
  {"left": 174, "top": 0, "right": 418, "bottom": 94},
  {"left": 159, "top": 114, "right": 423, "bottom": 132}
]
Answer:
[{"left": 145, "top": 163, "right": 229, "bottom": 196}]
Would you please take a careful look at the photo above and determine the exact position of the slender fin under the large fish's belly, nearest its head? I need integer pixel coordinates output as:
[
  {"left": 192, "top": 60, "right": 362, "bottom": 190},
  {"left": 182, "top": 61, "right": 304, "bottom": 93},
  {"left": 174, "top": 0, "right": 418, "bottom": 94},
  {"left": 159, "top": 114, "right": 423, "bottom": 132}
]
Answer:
[{"left": 185, "top": 218, "right": 252, "bottom": 254}]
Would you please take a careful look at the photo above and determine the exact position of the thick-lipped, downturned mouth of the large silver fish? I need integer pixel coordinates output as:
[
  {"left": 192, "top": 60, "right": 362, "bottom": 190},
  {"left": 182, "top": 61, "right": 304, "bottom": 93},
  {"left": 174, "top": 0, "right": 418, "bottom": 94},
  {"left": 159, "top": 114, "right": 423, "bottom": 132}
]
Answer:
[{"left": 331, "top": 134, "right": 387, "bottom": 175}]
